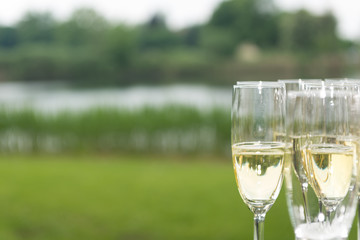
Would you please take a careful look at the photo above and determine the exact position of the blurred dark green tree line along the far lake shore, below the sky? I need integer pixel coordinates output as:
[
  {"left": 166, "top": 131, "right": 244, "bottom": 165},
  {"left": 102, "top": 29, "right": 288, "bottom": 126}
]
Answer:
[{"left": 0, "top": 0, "right": 358, "bottom": 84}]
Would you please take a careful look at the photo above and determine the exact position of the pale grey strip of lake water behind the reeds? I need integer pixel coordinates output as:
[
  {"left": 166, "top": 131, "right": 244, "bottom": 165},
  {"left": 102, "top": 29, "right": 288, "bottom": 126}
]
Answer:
[{"left": 0, "top": 83, "right": 232, "bottom": 112}]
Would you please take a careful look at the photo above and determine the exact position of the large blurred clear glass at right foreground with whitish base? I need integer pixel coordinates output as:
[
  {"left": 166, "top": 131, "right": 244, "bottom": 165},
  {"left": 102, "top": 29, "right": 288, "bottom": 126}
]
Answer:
[{"left": 285, "top": 81, "right": 358, "bottom": 240}]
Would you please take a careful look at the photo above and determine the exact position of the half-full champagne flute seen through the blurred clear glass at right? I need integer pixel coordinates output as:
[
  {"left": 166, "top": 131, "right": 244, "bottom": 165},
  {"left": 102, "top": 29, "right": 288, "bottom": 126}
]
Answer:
[{"left": 305, "top": 84, "right": 356, "bottom": 225}]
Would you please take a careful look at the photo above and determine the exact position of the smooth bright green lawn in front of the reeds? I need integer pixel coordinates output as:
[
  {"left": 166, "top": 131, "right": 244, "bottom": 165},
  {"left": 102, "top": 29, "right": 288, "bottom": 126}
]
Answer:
[{"left": 0, "top": 156, "right": 355, "bottom": 240}]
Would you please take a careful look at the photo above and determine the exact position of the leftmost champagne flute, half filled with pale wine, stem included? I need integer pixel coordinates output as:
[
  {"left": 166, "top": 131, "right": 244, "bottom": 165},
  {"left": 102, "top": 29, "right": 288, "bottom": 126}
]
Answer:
[{"left": 231, "top": 81, "right": 285, "bottom": 240}]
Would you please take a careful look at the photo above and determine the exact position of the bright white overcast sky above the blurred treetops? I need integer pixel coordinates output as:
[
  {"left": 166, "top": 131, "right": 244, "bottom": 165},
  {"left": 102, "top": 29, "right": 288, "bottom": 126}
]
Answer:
[{"left": 0, "top": 0, "right": 360, "bottom": 40}]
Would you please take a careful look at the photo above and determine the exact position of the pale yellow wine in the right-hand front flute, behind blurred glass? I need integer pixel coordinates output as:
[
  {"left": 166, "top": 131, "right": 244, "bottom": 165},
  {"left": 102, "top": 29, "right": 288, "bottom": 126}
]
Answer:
[{"left": 308, "top": 144, "right": 354, "bottom": 206}]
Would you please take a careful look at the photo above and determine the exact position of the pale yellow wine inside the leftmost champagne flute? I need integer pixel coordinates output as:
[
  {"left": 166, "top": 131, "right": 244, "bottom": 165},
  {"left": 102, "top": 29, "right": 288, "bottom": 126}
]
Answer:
[{"left": 232, "top": 142, "right": 285, "bottom": 207}]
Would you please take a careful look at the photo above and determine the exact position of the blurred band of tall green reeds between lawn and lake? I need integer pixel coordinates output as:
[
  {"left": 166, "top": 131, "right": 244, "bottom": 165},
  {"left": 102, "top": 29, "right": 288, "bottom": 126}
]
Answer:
[{"left": 0, "top": 105, "right": 230, "bottom": 155}]
